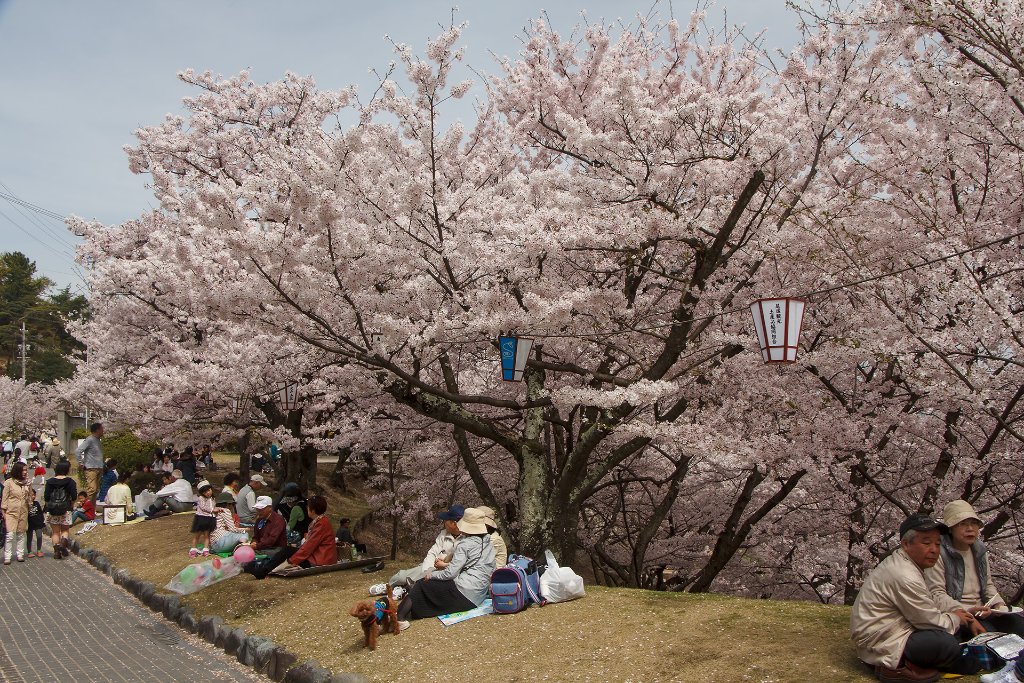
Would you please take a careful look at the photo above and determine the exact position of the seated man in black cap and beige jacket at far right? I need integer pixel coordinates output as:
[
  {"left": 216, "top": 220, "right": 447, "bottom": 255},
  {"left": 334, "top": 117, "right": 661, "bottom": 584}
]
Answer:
[{"left": 850, "top": 514, "right": 982, "bottom": 683}]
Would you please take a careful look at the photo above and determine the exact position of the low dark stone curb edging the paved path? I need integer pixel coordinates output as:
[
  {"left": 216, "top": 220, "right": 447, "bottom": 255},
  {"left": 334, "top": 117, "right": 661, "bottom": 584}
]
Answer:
[{"left": 71, "top": 539, "right": 370, "bottom": 683}]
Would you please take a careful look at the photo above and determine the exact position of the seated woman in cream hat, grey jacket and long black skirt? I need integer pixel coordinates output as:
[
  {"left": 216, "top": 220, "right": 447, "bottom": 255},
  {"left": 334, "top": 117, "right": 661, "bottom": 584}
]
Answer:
[{"left": 398, "top": 508, "right": 495, "bottom": 629}]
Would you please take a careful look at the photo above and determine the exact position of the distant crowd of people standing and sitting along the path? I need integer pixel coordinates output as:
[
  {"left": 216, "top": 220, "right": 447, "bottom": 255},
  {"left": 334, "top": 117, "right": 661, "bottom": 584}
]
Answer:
[{"left": 0, "top": 423, "right": 367, "bottom": 578}]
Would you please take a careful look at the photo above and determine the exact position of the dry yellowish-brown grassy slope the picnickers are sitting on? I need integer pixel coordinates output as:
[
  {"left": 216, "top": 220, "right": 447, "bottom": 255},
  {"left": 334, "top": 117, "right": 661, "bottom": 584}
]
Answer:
[{"left": 79, "top": 507, "right": 897, "bottom": 683}]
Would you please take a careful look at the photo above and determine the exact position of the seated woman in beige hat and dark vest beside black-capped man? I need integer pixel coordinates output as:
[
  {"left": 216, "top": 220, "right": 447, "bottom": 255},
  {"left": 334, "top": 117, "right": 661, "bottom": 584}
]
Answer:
[{"left": 925, "top": 501, "right": 1024, "bottom": 636}]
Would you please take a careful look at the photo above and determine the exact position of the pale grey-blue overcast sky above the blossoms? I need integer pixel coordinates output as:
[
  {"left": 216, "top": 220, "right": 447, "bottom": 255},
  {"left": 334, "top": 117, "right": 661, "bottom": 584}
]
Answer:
[{"left": 0, "top": 0, "right": 797, "bottom": 289}]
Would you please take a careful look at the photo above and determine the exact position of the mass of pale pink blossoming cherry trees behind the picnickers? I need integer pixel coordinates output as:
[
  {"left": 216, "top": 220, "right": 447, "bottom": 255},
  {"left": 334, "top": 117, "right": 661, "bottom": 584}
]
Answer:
[{"left": 68, "top": 3, "right": 1024, "bottom": 601}]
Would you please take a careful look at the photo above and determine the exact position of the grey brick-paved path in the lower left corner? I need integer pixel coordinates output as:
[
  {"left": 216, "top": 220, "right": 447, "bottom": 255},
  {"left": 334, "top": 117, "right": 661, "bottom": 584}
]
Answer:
[{"left": 0, "top": 543, "right": 269, "bottom": 683}]
